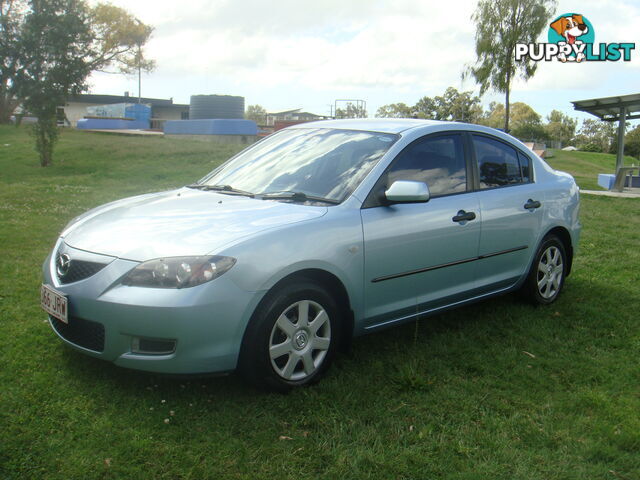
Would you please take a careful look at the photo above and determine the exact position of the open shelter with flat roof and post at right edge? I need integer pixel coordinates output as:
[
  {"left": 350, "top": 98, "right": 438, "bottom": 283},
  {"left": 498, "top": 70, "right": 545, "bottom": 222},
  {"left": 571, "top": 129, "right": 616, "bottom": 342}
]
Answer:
[{"left": 571, "top": 93, "right": 640, "bottom": 175}]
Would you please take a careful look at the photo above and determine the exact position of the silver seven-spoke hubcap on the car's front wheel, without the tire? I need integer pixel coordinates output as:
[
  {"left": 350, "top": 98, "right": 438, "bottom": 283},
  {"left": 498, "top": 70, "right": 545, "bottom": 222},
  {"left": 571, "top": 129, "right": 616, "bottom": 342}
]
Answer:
[{"left": 269, "top": 300, "right": 331, "bottom": 381}]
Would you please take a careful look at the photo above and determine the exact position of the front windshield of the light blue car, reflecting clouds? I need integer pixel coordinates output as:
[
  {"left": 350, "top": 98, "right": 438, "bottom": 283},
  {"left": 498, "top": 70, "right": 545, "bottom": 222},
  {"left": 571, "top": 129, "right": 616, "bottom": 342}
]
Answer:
[{"left": 199, "top": 128, "right": 397, "bottom": 203}]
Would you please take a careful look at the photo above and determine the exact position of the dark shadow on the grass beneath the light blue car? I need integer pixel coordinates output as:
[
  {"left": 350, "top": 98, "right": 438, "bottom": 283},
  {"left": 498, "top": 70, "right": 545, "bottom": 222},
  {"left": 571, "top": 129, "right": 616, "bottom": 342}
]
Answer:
[{"left": 57, "top": 277, "right": 620, "bottom": 404}]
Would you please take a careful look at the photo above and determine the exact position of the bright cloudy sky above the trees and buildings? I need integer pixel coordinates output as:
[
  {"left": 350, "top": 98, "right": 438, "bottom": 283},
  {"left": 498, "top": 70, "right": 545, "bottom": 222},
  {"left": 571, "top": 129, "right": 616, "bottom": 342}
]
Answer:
[{"left": 90, "top": 0, "right": 640, "bottom": 125}]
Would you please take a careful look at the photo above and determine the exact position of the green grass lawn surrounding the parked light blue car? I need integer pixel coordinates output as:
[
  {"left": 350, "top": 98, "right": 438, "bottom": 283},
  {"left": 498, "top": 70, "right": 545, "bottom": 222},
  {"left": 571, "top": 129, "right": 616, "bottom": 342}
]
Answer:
[{"left": 0, "top": 127, "right": 640, "bottom": 480}]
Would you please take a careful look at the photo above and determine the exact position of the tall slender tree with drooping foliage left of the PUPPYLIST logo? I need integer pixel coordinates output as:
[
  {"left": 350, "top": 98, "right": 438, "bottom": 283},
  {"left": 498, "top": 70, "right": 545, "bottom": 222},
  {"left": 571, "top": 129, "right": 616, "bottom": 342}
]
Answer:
[{"left": 462, "top": 0, "right": 556, "bottom": 132}]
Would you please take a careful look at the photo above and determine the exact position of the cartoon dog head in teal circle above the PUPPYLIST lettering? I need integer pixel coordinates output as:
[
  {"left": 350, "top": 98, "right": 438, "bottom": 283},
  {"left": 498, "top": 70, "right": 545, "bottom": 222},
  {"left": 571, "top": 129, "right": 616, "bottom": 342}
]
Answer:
[{"left": 549, "top": 13, "right": 595, "bottom": 62}]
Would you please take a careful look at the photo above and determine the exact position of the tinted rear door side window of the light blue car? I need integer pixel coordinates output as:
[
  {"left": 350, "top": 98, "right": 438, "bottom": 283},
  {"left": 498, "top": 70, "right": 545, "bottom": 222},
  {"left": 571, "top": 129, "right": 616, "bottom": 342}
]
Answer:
[{"left": 473, "top": 135, "right": 523, "bottom": 190}]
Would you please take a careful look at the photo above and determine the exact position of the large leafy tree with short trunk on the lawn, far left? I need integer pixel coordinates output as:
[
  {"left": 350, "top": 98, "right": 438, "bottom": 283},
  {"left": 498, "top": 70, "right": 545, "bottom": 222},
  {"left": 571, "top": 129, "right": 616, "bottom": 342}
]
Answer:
[{"left": 5, "top": 0, "right": 151, "bottom": 166}]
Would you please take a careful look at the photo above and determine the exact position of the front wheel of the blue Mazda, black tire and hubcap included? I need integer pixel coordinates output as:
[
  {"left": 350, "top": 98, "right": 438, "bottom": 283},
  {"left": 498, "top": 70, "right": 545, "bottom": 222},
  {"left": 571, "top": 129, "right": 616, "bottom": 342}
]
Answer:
[{"left": 239, "top": 280, "right": 342, "bottom": 392}]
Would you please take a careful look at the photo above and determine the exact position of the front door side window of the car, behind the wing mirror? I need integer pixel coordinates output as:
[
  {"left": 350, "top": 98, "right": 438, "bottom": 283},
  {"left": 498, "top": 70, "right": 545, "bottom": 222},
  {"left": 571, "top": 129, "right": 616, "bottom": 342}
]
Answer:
[{"left": 387, "top": 135, "right": 467, "bottom": 197}]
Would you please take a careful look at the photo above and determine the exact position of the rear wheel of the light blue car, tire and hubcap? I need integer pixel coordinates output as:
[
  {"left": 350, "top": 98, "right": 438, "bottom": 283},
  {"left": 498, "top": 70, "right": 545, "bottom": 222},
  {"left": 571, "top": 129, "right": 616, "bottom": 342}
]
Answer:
[{"left": 522, "top": 235, "right": 568, "bottom": 305}]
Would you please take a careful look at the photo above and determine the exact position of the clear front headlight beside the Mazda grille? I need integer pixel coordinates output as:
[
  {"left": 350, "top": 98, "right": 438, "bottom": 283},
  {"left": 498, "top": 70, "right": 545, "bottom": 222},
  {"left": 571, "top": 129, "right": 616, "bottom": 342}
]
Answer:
[{"left": 122, "top": 255, "right": 236, "bottom": 288}]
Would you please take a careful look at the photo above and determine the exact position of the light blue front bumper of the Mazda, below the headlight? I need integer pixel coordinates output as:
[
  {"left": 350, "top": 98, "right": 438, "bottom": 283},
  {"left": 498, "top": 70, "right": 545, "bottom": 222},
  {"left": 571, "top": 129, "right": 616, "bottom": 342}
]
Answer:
[{"left": 43, "top": 240, "right": 264, "bottom": 374}]
